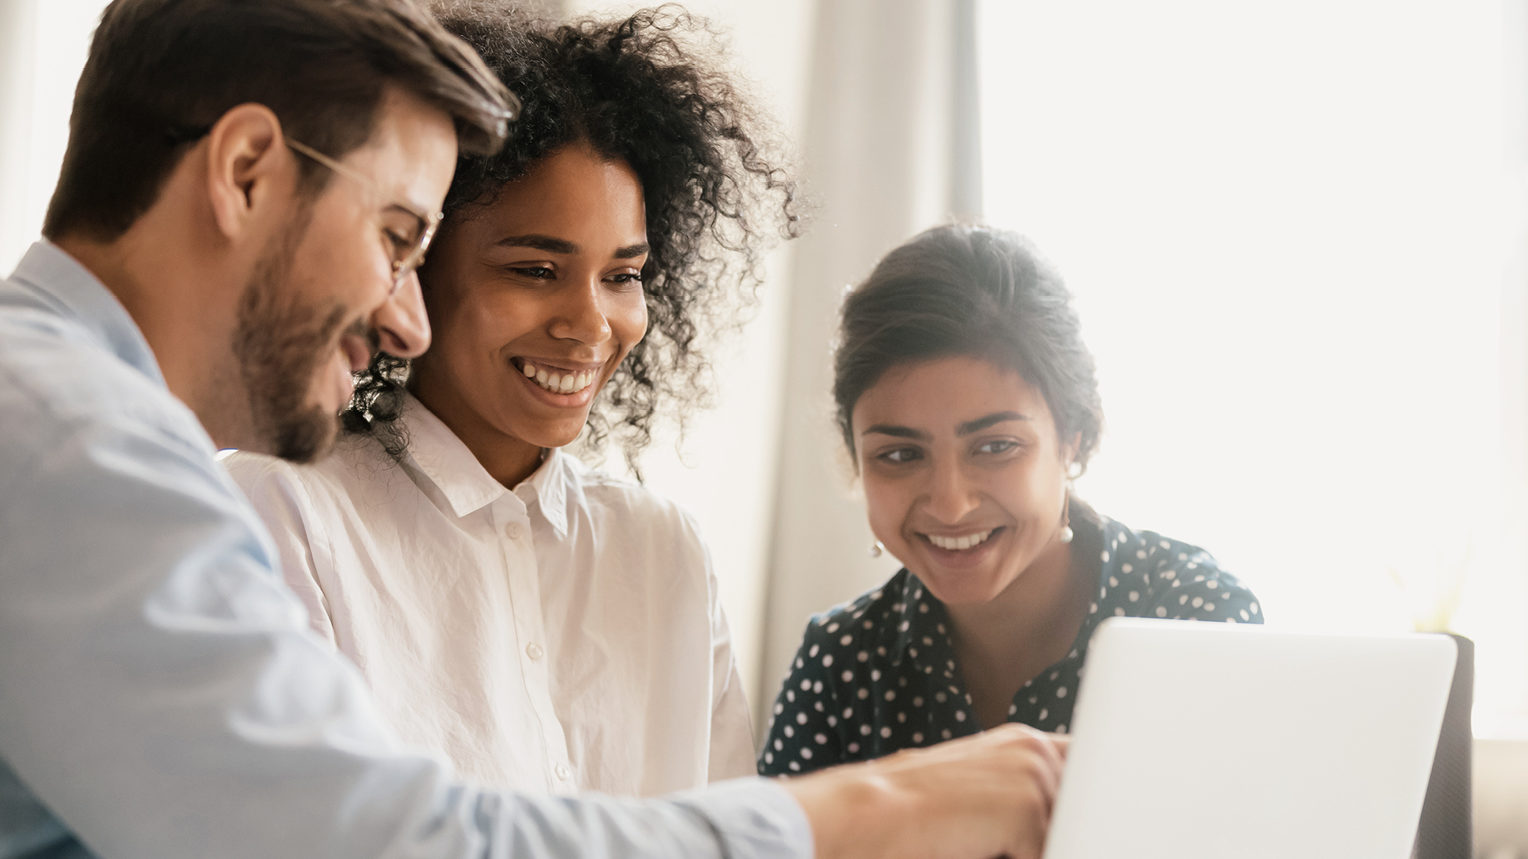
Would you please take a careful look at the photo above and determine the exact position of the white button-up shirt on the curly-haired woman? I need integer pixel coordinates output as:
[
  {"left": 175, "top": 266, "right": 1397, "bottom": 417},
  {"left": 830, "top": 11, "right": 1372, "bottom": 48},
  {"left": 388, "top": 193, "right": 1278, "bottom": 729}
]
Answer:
[{"left": 225, "top": 399, "right": 753, "bottom": 796}]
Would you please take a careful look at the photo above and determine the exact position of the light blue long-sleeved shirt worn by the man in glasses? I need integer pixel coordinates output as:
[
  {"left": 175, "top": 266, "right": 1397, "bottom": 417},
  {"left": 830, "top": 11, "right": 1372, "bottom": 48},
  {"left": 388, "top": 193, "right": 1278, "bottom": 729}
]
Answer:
[{"left": 0, "top": 241, "right": 811, "bottom": 859}]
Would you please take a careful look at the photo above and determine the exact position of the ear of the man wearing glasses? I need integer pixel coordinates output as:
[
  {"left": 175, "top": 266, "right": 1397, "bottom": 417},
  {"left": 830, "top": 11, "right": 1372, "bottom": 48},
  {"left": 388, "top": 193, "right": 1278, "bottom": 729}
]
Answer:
[{"left": 206, "top": 104, "right": 295, "bottom": 238}]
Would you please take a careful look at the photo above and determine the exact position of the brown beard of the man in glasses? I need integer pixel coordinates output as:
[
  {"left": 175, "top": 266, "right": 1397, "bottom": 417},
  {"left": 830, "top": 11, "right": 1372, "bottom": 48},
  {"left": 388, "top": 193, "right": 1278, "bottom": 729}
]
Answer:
[{"left": 232, "top": 224, "right": 376, "bottom": 462}]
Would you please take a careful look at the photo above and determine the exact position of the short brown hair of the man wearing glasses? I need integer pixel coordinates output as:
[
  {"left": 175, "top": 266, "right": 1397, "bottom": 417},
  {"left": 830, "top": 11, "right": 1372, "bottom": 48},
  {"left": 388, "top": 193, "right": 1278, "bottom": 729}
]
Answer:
[{"left": 43, "top": 0, "right": 516, "bottom": 241}]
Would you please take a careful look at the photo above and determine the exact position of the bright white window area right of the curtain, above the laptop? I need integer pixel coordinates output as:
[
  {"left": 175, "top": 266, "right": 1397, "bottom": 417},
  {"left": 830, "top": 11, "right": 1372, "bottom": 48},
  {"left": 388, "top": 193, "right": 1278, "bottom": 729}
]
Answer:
[{"left": 978, "top": 0, "right": 1528, "bottom": 721}]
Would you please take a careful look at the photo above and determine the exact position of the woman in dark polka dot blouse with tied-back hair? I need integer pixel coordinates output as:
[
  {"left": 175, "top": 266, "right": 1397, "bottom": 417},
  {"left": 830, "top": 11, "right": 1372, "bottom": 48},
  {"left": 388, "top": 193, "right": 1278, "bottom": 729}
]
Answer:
[{"left": 759, "top": 226, "right": 1262, "bottom": 775}]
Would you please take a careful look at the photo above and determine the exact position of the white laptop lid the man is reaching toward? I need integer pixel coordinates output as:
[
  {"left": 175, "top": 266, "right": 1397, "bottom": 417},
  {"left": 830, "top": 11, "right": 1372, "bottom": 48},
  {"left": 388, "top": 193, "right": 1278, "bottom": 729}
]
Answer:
[{"left": 1044, "top": 618, "right": 1455, "bottom": 859}]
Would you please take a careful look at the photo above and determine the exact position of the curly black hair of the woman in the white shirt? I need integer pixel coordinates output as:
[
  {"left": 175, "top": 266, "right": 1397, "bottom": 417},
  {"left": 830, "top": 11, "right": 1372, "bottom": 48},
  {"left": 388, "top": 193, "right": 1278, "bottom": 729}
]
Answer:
[{"left": 342, "top": 0, "right": 801, "bottom": 471}]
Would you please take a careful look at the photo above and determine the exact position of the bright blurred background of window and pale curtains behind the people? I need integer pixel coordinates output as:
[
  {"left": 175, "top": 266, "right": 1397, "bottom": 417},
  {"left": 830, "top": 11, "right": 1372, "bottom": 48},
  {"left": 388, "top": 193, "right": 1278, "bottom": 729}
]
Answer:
[{"left": 0, "top": 0, "right": 1528, "bottom": 843}]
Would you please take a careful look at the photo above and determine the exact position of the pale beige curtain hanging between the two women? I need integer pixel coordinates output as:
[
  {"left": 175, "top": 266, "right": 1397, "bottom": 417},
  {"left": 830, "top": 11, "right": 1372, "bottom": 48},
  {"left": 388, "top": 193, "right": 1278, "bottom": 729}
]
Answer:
[{"left": 755, "top": 0, "right": 979, "bottom": 726}]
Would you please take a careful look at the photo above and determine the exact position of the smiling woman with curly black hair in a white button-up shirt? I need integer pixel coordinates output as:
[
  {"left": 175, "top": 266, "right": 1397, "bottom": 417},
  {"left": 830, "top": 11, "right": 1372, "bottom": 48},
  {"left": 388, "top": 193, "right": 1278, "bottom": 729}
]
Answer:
[{"left": 229, "top": 3, "right": 796, "bottom": 795}]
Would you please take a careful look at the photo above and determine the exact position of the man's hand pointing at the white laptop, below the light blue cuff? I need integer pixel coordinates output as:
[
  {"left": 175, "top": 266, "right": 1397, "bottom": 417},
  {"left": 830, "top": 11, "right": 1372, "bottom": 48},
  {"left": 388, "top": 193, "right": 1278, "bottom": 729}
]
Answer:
[{"left": 784, "top": 724, "right": 1067, "bottom": 859}]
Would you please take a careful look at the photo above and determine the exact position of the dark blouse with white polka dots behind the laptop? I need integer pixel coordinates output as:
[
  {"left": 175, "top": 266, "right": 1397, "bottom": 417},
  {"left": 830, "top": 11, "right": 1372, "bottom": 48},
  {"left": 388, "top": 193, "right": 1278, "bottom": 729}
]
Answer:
[{"left": 759, "top": 511, "right": 1262, "bottom": 775}]
